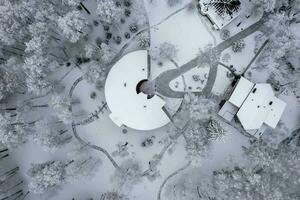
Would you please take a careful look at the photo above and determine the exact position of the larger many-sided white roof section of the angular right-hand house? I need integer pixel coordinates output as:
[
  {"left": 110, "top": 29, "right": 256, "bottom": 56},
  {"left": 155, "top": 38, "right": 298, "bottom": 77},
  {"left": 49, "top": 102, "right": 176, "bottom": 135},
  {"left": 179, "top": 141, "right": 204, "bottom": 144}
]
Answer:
[{"left": 237, "top": 84, "right": 285, "bottom": 130}]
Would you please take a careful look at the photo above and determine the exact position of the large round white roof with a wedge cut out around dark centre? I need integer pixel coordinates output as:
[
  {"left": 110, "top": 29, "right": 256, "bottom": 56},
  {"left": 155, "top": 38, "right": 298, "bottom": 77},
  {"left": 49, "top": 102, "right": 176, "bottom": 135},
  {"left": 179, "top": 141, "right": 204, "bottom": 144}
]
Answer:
[{"left": 105, "top": 50, "right": 170, "bottom": 130}]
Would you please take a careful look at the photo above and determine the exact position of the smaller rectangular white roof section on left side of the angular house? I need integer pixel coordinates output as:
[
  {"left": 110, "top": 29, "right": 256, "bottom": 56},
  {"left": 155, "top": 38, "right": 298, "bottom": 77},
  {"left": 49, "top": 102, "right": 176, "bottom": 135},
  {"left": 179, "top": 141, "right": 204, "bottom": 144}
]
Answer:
[{"left": 228, "top": 77, "right": 254, "bottom": 107}]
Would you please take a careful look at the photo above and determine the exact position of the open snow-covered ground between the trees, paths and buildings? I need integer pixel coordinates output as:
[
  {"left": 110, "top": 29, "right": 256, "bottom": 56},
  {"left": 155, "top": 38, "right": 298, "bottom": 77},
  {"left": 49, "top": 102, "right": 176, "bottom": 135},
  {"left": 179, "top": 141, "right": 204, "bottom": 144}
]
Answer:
[{"left": 2, "top": 0, "right": 300, "bottom": 200}]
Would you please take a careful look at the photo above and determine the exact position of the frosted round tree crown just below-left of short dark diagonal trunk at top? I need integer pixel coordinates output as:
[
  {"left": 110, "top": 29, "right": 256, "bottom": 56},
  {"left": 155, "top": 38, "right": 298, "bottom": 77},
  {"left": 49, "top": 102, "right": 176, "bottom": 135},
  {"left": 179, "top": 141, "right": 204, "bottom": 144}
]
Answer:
[{"left": 58, "top": 11, "right": 87, "bottom": 43}]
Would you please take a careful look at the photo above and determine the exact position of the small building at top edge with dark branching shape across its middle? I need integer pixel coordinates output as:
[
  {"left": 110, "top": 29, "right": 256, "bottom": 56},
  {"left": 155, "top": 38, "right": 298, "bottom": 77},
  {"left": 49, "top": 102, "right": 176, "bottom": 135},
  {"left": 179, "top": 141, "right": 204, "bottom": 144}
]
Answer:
[{"left": 198, "top": 0, "right": 244, "bottom": 30}]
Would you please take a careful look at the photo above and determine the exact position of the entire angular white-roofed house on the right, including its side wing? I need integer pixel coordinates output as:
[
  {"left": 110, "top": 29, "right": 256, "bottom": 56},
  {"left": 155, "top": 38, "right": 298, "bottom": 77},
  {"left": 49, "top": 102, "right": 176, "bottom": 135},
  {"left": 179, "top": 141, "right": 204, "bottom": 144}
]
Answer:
[{"left": 218, "top": 77, "right": 286, "bottom": 138}]
